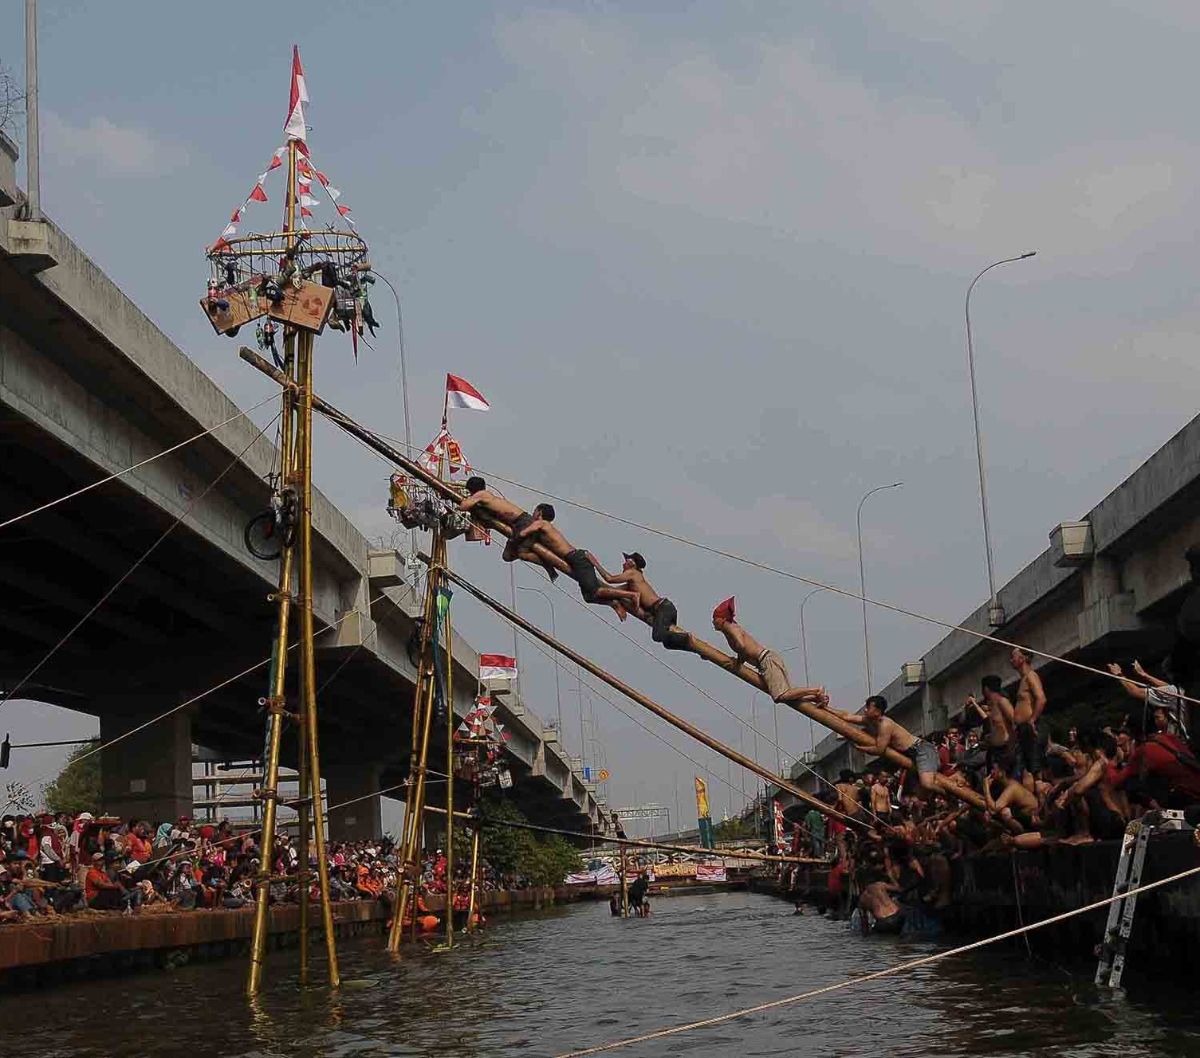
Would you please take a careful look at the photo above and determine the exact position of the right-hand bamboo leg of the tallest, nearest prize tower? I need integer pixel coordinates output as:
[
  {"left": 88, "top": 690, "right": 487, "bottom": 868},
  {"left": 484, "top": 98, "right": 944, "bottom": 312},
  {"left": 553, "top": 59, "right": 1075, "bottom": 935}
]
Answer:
[{"left": 296, "top": 331, "right": 341, "bottom": 988}]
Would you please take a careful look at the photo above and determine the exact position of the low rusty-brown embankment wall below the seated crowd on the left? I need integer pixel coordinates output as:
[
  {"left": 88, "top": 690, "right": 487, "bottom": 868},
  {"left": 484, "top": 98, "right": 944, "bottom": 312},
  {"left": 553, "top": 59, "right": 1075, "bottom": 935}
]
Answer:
[{"left": 0, "top": 886, "right": 578, "bottom": 990}]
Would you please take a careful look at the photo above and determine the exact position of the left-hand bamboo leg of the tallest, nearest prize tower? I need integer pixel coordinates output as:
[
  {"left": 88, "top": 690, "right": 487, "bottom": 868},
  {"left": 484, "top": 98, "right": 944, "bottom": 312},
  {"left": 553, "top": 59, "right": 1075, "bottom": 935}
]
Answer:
[{"left": 246, "top": 336, "right": 295, "bottom": 996}]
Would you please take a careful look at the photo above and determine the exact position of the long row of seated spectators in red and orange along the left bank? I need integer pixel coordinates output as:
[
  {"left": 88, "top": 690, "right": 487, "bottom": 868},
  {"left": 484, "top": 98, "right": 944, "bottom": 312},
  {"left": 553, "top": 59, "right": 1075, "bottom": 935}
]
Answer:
[{"left": 0, "top": 812, "right": 511, "bottom": 922}]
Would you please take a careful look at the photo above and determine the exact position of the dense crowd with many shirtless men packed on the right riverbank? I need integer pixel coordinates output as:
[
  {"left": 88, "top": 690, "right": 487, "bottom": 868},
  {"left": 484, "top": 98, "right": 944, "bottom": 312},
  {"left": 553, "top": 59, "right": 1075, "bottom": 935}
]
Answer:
[{"left": 784, "top": 651, "right": 1200, "bottom": 932}]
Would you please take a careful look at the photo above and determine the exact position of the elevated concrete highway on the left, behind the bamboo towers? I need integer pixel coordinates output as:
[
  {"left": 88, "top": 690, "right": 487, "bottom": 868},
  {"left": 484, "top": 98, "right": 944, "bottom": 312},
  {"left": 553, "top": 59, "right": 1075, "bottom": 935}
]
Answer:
[{"left": 0, "top": 133, "right": 598, "bottom": 836}]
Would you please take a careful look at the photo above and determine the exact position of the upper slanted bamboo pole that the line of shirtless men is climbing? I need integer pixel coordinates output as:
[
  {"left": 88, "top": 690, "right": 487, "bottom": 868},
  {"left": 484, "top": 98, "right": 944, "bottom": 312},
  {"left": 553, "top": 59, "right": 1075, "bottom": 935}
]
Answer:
[{"left": 240, "top": 347, "right": 984, "bottom": 808}]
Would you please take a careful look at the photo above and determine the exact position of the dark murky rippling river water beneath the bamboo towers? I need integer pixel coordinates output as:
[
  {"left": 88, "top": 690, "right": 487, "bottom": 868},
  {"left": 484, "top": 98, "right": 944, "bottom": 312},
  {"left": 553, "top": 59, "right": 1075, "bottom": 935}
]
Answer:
[{"left": 11, "top": 894, "right": 1200, "bottom": 1058}]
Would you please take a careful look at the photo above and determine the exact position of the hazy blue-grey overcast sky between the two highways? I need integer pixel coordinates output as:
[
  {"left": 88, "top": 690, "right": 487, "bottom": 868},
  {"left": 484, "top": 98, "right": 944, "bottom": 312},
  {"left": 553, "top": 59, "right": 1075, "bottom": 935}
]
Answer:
[{"left": 0, "top": 0, "right": 1200, "bottom": 816}]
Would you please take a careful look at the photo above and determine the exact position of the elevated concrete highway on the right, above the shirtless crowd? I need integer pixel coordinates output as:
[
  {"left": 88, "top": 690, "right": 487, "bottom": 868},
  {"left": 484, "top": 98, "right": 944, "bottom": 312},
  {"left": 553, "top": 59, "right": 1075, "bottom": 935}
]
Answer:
[{"left": 792, "top": 388, "right": 1200, "bottom": 789}]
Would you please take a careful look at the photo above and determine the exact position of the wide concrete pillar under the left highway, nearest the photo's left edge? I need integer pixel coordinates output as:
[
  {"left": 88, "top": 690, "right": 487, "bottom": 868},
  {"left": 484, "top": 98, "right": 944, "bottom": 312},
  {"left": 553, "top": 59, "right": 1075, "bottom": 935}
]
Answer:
[{"left": 100, "top": 696, "right": 192, "bottom": 823}]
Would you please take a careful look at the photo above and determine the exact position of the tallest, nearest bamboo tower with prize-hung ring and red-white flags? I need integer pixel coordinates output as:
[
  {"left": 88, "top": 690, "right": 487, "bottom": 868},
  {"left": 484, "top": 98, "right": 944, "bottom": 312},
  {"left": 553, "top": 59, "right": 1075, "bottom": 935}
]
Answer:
[{"left": 208, "top": 47, "right": 370, "bottom": 996}]
